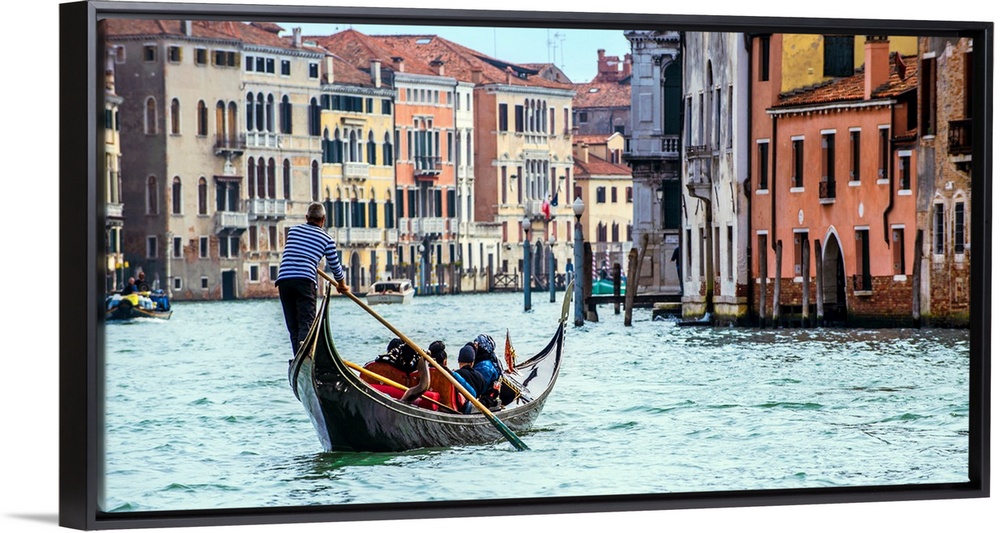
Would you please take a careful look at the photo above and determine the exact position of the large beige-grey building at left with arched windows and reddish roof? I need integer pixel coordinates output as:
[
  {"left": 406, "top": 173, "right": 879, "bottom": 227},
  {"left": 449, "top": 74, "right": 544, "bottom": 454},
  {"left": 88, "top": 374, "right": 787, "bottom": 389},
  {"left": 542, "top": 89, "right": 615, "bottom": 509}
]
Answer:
[{"left": 104, "top": 19, "right": 248, "bottom": 300}]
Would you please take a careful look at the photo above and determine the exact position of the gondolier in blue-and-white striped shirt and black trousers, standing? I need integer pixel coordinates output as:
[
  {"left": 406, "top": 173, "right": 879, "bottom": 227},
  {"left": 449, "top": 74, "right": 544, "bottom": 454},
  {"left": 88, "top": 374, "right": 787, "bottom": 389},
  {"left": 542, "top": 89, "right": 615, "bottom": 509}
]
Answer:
[{"left": 274, "top": 202, "right": 350, "bottom": 357}]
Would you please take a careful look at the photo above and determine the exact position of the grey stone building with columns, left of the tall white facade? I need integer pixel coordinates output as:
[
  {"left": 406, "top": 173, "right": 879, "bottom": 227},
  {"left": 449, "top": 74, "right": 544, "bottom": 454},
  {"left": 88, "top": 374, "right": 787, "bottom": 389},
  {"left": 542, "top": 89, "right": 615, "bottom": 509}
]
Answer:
[{"left": 625, "top": 31, "right": 682, "bottom": 294}]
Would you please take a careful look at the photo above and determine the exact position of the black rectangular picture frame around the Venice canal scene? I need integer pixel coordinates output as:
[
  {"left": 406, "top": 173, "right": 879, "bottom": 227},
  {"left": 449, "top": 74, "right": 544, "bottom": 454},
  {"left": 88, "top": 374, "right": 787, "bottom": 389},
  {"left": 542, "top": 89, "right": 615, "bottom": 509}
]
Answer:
[{"left": 59, "top": 2, "right": 995, "bottom": 530}]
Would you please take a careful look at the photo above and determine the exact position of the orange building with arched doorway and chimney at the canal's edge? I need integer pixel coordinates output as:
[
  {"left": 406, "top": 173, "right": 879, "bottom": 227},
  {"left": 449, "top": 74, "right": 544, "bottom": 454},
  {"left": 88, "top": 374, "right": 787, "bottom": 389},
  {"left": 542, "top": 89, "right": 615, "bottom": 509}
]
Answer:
[{"left": 750, "top": 35, "right": 917, "bottom": 324}]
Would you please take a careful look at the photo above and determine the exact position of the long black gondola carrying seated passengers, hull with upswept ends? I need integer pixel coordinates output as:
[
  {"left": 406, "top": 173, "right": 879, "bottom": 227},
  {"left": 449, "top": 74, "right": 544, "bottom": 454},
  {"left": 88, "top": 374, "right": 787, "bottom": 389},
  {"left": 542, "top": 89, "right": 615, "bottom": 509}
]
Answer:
[{"left": 288, "top": 280, "right": 571, "bottom": 452}]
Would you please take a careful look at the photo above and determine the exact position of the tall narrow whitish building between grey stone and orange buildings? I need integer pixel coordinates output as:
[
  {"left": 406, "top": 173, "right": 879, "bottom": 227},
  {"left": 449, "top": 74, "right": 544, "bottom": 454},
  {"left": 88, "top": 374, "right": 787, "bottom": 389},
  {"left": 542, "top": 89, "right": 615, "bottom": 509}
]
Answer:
[{"left": 670, "top": 32, "right": 750, "bottom": 324}]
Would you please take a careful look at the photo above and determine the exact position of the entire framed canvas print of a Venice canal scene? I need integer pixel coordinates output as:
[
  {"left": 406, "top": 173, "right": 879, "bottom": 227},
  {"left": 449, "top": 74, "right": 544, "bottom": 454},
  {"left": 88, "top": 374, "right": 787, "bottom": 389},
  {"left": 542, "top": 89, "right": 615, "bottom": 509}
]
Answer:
[{"left": 58, "top": 1, "right": 994, "bottom": 530}]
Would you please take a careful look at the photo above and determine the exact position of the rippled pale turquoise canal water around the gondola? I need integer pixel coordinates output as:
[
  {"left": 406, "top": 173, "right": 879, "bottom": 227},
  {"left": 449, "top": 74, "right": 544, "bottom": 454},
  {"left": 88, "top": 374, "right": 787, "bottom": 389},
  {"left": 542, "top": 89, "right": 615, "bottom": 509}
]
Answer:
[{"left": 103, "top": 293, "right": 969, "bottom": 511}]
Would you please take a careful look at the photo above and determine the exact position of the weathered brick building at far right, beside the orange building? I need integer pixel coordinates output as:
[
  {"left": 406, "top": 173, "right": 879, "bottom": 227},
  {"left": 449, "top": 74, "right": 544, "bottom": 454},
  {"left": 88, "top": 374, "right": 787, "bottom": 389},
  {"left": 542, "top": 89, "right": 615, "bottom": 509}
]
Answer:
[{"left": 913, "top": 37, "right": 976, "bottom": 326}]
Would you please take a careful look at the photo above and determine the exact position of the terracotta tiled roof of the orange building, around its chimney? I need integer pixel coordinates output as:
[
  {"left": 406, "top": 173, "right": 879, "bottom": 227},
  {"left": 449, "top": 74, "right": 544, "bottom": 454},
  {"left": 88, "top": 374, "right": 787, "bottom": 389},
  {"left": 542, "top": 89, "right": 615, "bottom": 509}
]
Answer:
[{"left": 774, "top": 52, "right": 917, "bottom": 108}]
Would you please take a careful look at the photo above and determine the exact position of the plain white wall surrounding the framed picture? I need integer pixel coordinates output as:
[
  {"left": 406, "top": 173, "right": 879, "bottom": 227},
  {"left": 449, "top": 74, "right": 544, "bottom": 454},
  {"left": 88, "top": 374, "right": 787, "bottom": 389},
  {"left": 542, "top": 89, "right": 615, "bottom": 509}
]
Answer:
[{"left": 0, "top": 0, "right": 1000, "bottom": 533}]
